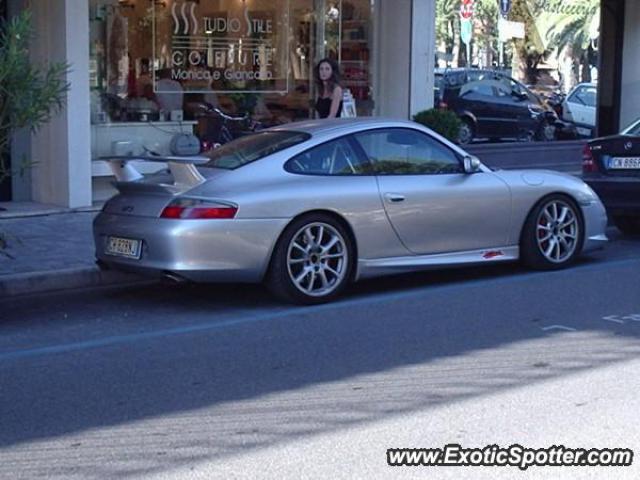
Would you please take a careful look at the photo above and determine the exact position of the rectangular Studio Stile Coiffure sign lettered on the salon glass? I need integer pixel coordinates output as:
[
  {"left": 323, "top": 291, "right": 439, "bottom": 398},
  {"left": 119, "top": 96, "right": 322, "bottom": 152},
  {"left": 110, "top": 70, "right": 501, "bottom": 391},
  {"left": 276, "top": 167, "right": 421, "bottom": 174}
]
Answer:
[{"left": 152, "top": 0, "right": 289, "bottom": 93}]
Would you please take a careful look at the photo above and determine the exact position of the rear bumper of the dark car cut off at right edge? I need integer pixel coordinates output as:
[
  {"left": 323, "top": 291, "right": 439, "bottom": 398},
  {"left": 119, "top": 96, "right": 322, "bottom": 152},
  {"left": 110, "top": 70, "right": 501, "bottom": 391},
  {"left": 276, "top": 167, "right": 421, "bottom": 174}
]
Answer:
[{"left": 584, "top": 177, "right": 640, "bottom": 217}]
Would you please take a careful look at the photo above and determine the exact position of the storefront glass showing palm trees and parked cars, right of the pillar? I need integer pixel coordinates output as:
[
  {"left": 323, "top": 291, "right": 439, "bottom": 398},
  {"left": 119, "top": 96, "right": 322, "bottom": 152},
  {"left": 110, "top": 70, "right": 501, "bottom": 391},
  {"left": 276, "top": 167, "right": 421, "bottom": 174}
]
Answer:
[{"left": 434, "top": 0, "right": 600, "bottom": 143}]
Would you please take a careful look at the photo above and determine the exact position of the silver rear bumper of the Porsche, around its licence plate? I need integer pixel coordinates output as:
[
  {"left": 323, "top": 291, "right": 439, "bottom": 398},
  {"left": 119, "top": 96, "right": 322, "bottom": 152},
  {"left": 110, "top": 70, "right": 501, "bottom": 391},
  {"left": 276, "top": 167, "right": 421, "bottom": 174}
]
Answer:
[{"left": 93, "top": 213, "right": 287, "bottom": 282}]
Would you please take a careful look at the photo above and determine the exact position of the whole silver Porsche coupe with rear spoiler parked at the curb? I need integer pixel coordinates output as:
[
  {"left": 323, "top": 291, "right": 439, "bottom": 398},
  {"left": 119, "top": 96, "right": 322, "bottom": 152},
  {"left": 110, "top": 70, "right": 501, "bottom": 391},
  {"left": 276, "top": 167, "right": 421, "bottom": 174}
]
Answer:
[{"left": 94, "top": 118, "right": 607, "bottom": 303}]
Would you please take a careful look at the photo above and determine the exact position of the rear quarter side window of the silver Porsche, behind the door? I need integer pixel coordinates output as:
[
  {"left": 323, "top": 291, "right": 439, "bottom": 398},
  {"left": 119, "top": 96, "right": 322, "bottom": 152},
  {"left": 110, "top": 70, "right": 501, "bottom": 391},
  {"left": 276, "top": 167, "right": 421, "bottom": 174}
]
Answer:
[{"left": 284, "top": 138, "right": 371, "bottom": 175}]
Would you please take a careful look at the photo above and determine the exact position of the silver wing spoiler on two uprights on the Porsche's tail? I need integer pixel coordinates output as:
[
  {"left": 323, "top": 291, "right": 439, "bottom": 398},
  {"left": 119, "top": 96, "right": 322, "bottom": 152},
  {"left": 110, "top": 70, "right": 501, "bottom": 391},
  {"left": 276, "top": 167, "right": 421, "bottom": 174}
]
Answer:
[{"left": 99, "top": 155, "right": 210, "bottom": 187}]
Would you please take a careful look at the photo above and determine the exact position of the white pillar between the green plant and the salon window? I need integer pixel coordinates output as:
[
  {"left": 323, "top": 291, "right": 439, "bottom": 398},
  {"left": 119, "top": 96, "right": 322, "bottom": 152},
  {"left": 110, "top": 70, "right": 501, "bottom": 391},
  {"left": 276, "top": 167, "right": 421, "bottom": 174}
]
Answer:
[{"left": 31, "top": 0, "right": 91, "bottom": 208}]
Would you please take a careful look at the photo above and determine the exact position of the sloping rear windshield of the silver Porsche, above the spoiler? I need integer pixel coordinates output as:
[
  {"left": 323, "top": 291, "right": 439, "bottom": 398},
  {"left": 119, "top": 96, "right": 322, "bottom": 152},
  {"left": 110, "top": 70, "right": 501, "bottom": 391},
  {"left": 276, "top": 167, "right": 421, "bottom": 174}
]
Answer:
[{"left": 202, "top": 131, "right": 311, "bottom": 170}]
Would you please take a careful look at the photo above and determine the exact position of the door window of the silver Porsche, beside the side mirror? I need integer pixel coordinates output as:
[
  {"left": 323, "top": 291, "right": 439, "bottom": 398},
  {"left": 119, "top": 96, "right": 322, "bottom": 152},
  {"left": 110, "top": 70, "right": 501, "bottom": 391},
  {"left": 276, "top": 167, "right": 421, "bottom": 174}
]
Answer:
[{"left": 355, "top": 128, "right": 462, "bottom": 175}]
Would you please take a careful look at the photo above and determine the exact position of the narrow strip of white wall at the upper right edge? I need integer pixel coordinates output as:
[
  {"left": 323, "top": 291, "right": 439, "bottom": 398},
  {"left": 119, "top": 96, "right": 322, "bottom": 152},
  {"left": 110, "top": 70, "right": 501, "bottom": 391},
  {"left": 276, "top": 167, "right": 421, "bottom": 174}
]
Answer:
[{"left": 620, "top": 0, "right": 640, "bottom": 129}]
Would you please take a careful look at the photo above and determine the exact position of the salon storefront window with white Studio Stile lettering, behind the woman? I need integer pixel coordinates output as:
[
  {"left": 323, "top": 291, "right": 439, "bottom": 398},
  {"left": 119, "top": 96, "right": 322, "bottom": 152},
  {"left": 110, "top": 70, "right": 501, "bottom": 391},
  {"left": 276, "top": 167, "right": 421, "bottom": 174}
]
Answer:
[{"left": 85, "top": 0, "right": 374, "bottom": 175}]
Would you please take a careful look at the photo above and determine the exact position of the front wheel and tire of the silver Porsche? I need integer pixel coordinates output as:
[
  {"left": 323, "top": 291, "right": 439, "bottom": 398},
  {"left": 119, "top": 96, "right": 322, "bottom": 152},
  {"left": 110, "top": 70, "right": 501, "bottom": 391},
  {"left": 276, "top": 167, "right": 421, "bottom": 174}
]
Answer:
[{"left": 520, "top": 194, "right": 584, "bottom": 270}]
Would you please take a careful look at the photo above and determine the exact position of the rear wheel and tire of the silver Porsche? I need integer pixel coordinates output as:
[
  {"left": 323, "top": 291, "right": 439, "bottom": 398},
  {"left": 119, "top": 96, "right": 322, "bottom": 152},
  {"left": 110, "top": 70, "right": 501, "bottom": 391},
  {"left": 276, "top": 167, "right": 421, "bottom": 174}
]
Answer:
[{"left": 265, "top": 213, "right": 356, "bottom": 305}]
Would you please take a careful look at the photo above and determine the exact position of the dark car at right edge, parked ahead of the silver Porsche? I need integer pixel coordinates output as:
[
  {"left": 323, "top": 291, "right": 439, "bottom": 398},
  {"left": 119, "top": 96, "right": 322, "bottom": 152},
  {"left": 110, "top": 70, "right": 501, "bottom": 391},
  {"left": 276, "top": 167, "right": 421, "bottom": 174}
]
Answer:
[{"left": 582, "top": 119, "right": 640, "bottom": 235}]
